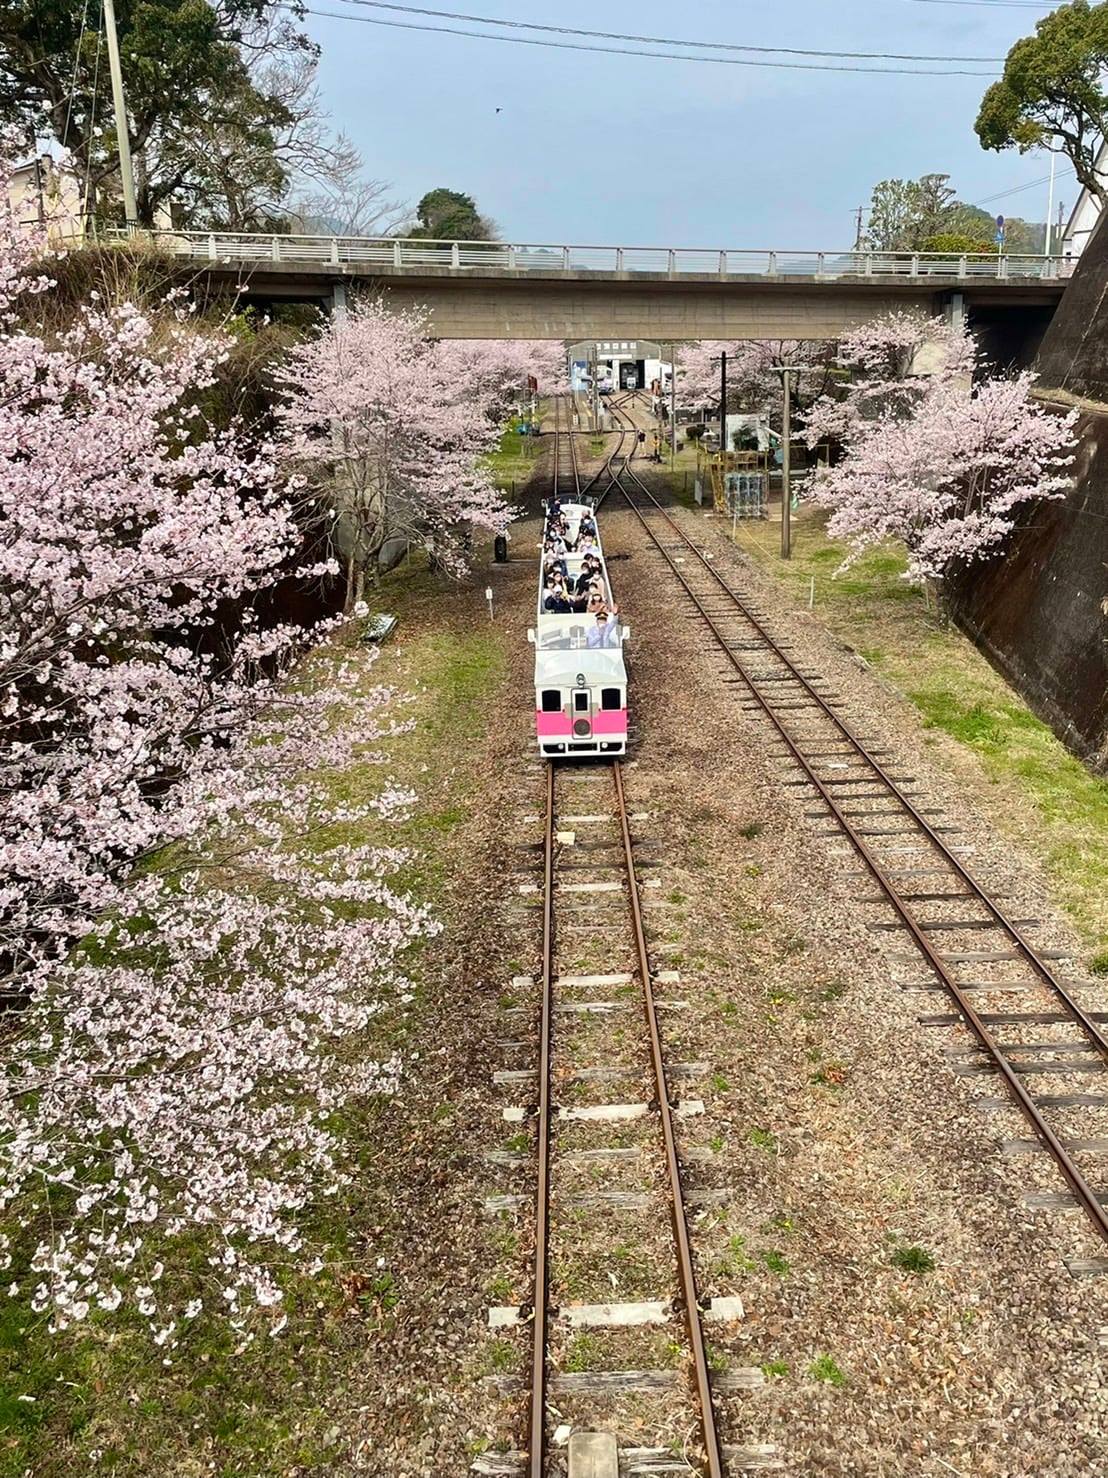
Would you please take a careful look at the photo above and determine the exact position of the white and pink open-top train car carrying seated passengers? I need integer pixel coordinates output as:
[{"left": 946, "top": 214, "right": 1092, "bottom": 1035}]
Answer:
[{"left": 527, "top": 503, "right": 631, "bottom": 758}]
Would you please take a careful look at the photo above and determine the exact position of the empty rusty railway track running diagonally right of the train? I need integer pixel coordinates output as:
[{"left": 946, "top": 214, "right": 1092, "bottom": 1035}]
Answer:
[{"left": 612, "top": 399, "right": 1108, "bottom": 1274}]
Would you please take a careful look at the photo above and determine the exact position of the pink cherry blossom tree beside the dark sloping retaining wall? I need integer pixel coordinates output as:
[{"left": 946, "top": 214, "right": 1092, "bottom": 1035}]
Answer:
[{"left": 807, "top": 313, "right": 1077, "bottom": 579}]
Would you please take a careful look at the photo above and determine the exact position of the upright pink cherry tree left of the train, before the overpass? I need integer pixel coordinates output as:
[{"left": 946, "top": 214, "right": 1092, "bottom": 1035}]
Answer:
[{"left": 279, "top": 299, "right": 520, "bottom": 606}]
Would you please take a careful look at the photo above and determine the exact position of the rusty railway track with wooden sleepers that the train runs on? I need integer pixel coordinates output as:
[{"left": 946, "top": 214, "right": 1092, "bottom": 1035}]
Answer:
[{"left": 505, "top": 408, "right": 779, "bottom": 1478}]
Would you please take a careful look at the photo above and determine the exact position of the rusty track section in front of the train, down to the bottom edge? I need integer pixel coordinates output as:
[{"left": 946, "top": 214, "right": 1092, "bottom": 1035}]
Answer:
[{"left": 517, "top": 761, "right": 728, "bottom": 1478}]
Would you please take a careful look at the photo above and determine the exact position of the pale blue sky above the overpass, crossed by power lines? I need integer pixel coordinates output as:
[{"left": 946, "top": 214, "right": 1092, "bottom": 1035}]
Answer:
[{"left": 306, "top": 0, "right": 1077, "bottom": 250}]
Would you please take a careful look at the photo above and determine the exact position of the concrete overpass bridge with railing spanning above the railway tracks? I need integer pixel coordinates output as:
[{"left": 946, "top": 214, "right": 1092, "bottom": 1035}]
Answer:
[{"left": 130, "top": 231, "right": 1071, "bottom": 347}]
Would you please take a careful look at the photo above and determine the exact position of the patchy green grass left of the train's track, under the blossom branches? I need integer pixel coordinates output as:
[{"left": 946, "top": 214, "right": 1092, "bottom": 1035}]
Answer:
[{"left": 0, "top": 585, "right": 511, "bottom": 1478}]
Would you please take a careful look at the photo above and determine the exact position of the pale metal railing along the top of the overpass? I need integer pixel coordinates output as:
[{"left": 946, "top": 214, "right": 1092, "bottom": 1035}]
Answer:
[{"left": 108, "top": 231, "right": 1073, "bottom": 281}]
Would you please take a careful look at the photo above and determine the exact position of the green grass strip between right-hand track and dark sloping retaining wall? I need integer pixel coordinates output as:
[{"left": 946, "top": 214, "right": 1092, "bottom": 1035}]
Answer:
[{"left": 739, "top": 508, "right": 1108, "bottom": 973}]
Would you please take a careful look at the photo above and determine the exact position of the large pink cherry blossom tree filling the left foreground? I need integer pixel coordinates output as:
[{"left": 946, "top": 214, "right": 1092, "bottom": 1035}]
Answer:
[{"left": 0, "top": 164, "right": 431, "bottom": 1349}]
